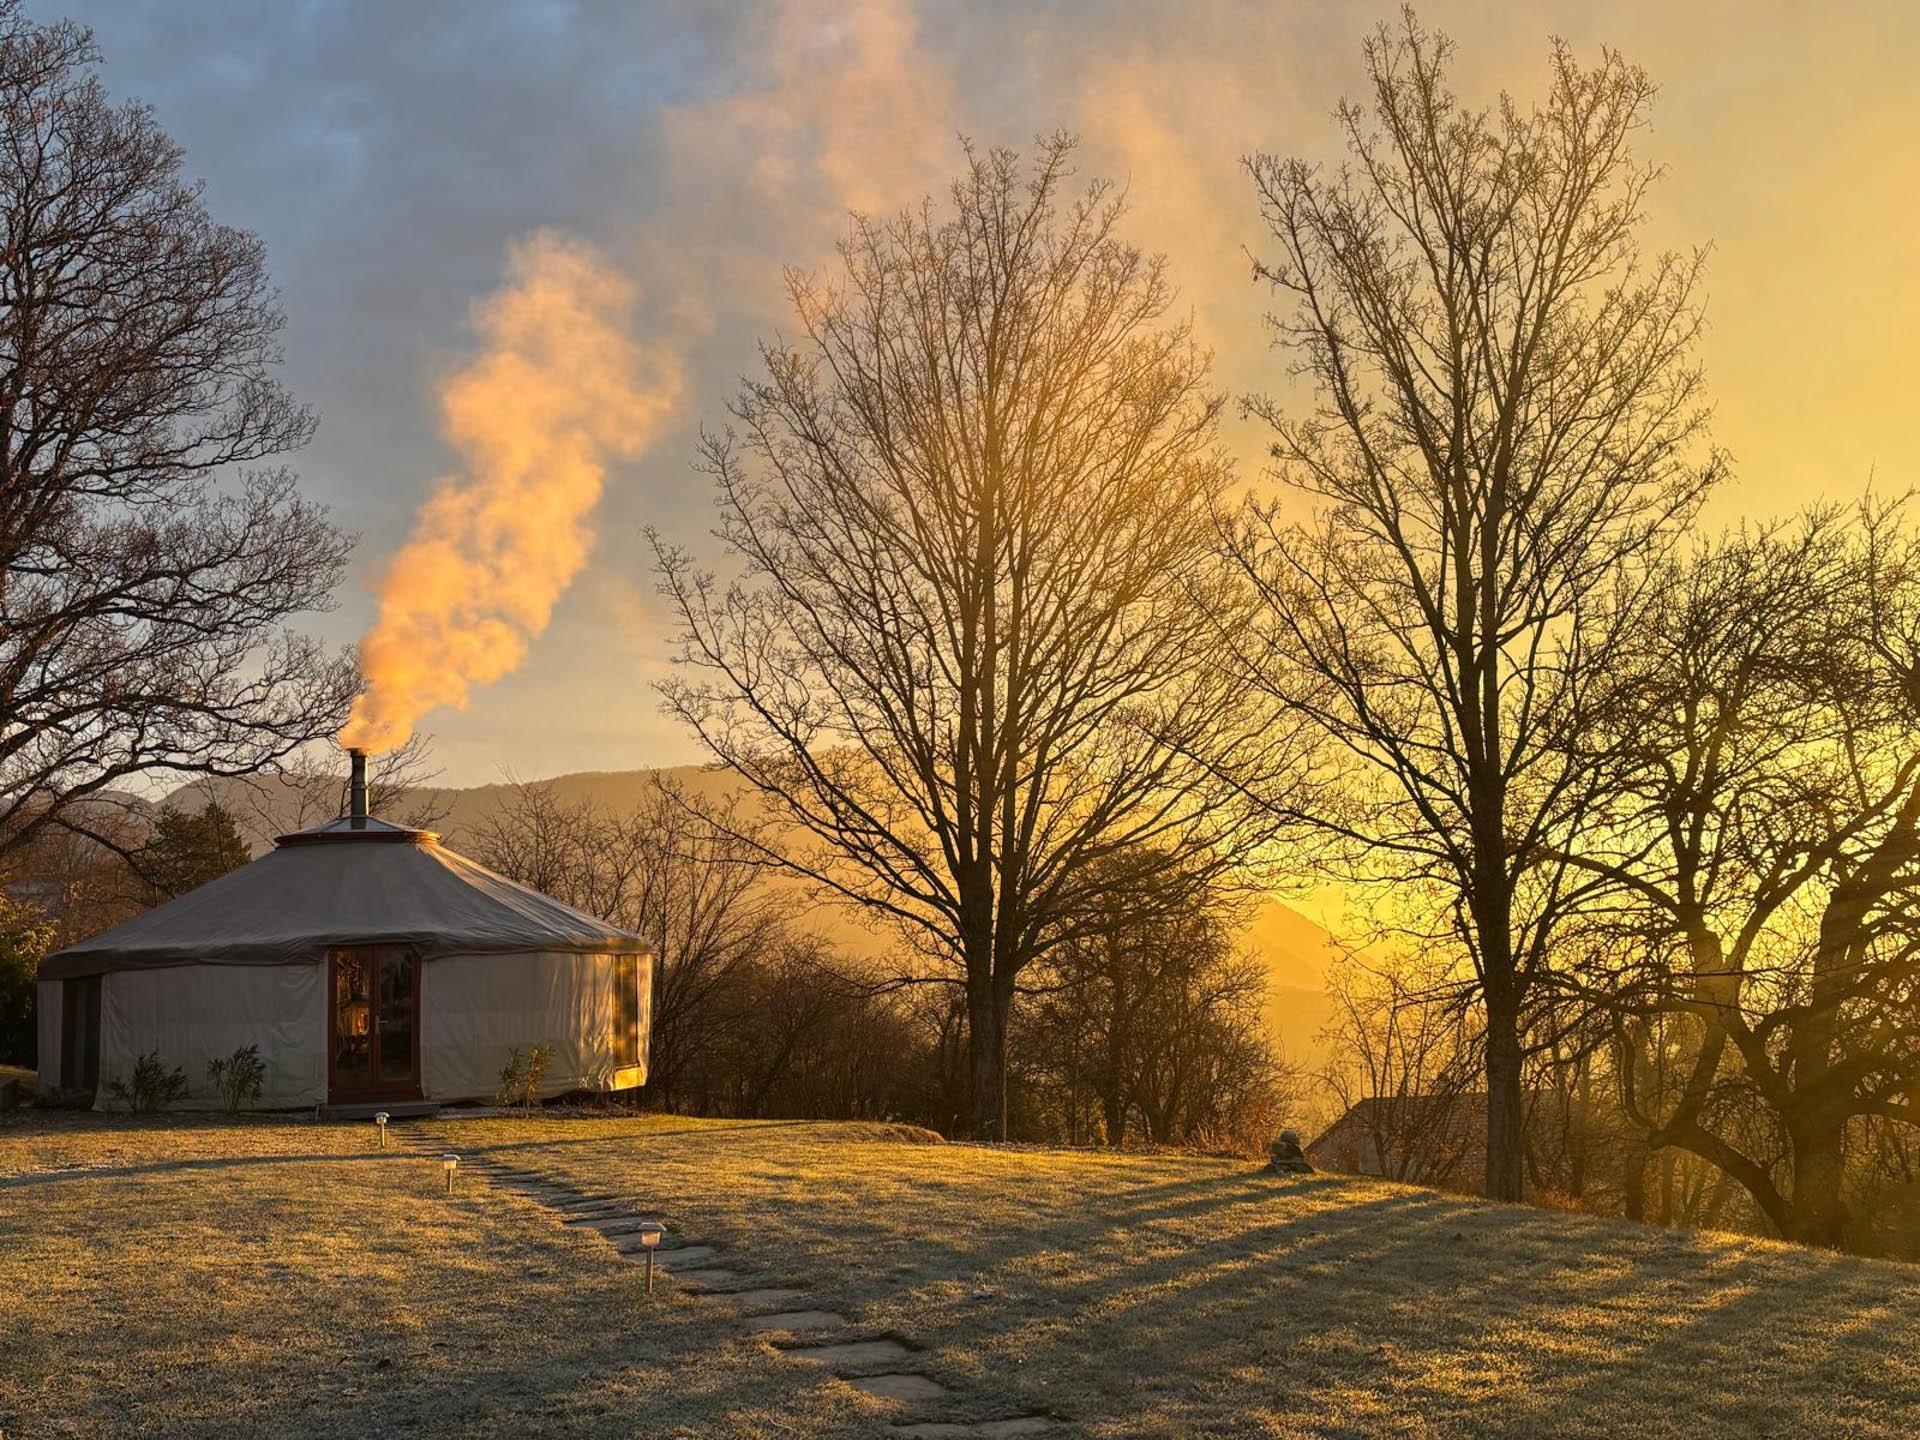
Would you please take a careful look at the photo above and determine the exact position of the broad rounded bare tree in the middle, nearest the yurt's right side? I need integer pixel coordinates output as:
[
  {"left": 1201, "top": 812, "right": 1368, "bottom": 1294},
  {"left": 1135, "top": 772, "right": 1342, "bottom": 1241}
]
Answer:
[{"left": 655, "top": 138, "right": 1263, "bottom": 1135}]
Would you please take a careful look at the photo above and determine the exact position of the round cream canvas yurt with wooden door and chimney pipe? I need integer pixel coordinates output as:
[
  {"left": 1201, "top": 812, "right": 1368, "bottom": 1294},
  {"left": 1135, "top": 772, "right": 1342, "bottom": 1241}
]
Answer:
[{"left": 38, "top": 755, "right": 653, "bottom": 1114}]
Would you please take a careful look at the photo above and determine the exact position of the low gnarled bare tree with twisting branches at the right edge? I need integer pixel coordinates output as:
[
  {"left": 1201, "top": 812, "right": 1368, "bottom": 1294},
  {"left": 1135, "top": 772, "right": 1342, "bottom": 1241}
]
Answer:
[{"left": 1572, "top": 503, "right": 1920, "bottom": 1244}]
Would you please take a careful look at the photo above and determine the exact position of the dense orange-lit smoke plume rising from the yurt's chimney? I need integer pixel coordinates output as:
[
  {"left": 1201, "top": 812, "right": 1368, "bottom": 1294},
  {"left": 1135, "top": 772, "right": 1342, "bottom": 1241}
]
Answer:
[{"left": 340, "top": 230, "right": 680, "bottom": 751}]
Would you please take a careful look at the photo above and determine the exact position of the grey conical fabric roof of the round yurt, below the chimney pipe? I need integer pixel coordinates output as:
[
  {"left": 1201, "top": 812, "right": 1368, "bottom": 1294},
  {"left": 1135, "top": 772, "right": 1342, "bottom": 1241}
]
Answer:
[{"left": 40, "top": 818, "right": 647, "bottom": 979}]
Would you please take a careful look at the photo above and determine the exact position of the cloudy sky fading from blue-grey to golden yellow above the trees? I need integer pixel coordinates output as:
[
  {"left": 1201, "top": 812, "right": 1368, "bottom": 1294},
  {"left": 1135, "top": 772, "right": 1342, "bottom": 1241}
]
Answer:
[{"left": 56, "top": 0, "right": 1920, "bottom": 785}]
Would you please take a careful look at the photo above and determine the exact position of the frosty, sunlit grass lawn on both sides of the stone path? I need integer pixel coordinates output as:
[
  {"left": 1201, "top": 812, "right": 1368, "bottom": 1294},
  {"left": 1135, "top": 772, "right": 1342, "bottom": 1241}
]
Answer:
[{"left": 0, "top": 1116, "right": 1920, "bottom": 1440}]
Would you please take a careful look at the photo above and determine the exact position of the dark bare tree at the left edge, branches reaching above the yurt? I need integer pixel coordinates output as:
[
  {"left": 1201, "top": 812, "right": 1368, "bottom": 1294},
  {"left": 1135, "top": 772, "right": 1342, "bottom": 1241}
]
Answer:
[{"left": 0, "top": 0, "right": 353, "bottom": 867}]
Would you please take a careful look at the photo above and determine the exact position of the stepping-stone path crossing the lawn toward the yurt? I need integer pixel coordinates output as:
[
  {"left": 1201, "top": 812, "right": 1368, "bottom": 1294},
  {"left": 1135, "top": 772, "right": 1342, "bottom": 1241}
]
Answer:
[{"left": 430, "top": 1137, "right": 1064, "bottom": 1440}]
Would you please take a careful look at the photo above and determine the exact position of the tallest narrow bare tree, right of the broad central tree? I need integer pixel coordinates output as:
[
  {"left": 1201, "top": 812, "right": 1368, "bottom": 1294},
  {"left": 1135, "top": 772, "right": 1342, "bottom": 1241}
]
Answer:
[{"left": 1229, "top": 12, "right": 1716, "bottom": 1200}]
